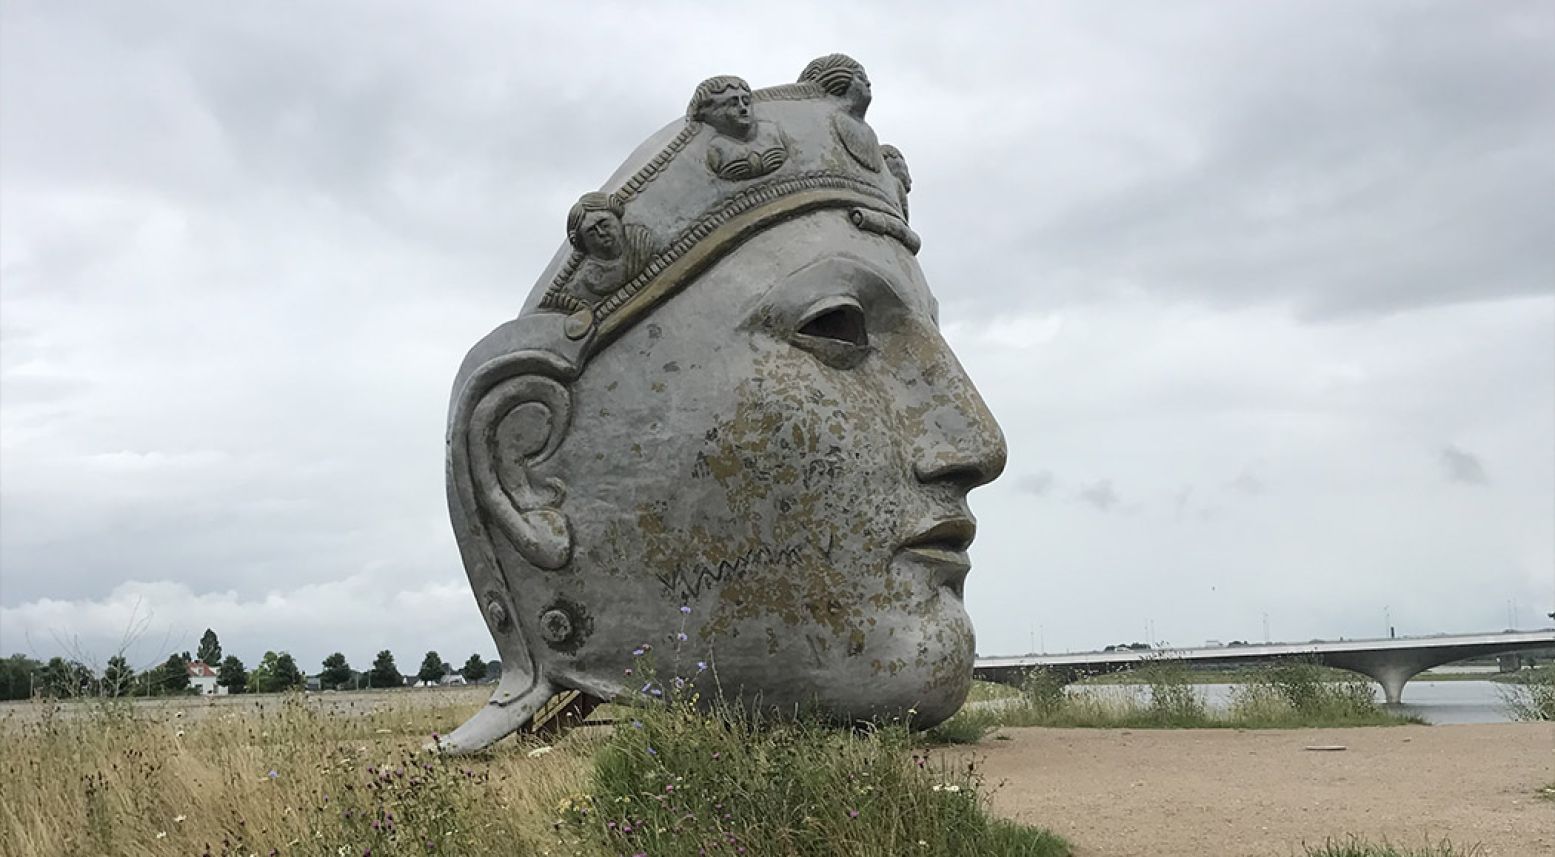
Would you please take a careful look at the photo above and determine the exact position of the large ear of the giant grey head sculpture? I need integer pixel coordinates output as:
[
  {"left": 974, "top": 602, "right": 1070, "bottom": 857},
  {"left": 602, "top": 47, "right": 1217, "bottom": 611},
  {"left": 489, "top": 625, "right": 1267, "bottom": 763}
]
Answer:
[{"left": 462, "top": 365, "right": 572, "bottom": 571}]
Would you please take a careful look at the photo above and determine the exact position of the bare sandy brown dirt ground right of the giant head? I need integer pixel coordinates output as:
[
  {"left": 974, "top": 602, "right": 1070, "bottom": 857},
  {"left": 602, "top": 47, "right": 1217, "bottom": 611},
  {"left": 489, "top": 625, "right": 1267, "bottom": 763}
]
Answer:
[{"left": 972, "top": 723, "right": 1555, "bottom": 857}]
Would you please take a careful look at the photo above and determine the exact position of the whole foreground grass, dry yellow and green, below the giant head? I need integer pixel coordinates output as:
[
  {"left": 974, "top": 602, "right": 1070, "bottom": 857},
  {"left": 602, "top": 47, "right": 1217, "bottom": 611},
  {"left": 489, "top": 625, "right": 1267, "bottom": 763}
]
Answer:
[{"left": 0, "top": 691, "right": 1068, "bottom": 857}]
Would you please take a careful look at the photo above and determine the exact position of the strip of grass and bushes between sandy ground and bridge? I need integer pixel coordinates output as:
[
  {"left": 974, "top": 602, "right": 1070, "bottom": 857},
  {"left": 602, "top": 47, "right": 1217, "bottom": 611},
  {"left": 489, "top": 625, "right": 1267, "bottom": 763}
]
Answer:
[{"left": 933, "top": 659, "right": 1421, "bottom": 743}]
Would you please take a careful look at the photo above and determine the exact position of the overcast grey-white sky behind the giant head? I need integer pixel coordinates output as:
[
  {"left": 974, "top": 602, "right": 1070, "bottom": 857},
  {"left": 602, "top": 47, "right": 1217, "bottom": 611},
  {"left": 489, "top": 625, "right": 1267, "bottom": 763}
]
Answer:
[{"left": 0, "top": 0, "right": 1555, "bottom": 670}]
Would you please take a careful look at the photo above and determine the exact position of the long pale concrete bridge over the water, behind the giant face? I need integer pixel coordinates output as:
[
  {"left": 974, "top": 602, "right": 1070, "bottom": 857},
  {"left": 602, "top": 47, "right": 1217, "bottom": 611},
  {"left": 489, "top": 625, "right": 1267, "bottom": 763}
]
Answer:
[{"left": 972, "top": 628, "right": 1555, "bottom": 703}]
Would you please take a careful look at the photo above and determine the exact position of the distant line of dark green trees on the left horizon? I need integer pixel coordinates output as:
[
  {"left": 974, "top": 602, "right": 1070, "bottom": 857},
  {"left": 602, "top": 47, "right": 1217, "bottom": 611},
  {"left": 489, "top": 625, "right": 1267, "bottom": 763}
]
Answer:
[{"left": 0, "top": 628, "right": 502, "bottom": 700}]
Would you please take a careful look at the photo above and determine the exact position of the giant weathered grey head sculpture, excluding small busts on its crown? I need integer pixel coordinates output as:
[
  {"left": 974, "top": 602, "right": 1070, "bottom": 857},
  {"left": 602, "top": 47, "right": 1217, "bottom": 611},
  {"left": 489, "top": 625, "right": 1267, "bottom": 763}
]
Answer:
[{"left": 443, "top": 53, "right": 1005, "bottom": 751}]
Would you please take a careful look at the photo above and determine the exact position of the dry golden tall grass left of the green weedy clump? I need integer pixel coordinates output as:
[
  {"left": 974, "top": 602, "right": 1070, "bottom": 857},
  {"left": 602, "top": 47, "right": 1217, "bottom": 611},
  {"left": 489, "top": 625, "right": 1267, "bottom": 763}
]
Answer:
[{"left": 0, "top": 695, "right": 586, "bottom": 857}]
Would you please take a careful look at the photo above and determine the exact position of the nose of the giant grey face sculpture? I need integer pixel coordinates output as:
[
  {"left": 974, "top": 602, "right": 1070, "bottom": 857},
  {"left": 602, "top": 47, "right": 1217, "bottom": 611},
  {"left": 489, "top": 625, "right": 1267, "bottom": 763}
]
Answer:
[{"left": 910, "top": 331, "right": 1009, "bottom": 491}]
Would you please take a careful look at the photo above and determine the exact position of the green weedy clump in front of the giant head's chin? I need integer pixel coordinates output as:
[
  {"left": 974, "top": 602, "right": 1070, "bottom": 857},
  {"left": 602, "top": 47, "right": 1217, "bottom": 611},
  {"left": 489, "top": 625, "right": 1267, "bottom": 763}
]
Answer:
[{"left": 561, "top": 681, "right": 1068, "bottom": 857}]
